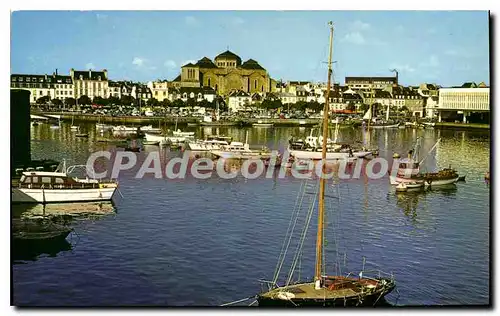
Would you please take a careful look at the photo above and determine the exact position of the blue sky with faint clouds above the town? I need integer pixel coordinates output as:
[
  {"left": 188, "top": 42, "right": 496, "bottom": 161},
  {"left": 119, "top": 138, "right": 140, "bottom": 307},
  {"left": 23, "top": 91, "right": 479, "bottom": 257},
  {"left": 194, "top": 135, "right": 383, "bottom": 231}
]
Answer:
[{"left": 11, "top": 11, "right": 489, "bottom": 86}]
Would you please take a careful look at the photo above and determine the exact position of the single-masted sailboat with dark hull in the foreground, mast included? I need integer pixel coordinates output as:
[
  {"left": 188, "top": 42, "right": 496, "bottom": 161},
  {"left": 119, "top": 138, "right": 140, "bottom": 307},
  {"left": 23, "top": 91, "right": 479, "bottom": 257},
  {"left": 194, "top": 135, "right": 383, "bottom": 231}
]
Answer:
[{"left": 257, "top": 22, "right": 396, "bottom": 306}]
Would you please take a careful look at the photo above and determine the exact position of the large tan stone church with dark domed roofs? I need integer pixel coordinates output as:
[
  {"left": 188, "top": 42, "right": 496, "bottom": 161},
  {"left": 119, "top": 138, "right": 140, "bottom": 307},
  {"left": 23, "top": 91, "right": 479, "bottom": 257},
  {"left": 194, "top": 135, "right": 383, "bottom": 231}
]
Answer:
[{"left": 177, "top": 50, "right": 271, "bottom": 95}]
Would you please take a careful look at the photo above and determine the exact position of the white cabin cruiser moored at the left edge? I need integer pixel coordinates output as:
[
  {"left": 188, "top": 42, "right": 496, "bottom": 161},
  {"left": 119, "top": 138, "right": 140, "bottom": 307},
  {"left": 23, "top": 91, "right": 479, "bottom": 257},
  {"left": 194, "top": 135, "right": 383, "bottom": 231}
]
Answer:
[{"left": 12, "top": 161, "right": 118, "bottom": 204}]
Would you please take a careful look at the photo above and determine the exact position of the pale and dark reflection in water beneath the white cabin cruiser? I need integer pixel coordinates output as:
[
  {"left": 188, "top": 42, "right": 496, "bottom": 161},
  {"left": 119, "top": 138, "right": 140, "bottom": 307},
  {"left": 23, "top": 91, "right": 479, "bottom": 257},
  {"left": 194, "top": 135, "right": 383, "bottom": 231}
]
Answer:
[{"left": 11, "top": 202, "right": 115, "bottom": 263}]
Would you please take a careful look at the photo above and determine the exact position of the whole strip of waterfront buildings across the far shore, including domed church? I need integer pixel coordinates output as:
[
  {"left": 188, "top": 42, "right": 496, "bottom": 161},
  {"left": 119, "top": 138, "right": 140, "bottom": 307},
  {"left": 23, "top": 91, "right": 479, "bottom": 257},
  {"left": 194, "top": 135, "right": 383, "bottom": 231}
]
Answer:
[{"left": 11, "top": 66, "right": 490, "bottom": 118}]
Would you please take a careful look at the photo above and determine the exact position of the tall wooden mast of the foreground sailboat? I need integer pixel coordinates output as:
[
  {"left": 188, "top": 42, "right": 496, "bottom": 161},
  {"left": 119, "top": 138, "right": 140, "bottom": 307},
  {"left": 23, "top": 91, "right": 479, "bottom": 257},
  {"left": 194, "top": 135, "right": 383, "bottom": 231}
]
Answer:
[{"left": 314, "top": 21, "right": 333, "bottom": 289}]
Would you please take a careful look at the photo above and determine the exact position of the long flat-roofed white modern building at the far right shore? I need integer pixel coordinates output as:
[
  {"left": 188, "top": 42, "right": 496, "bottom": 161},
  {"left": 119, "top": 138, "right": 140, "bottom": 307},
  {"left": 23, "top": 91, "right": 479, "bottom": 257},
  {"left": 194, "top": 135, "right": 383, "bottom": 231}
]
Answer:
[{"left": 437, "top": 87, "right": 490, "bottom": 123}]
